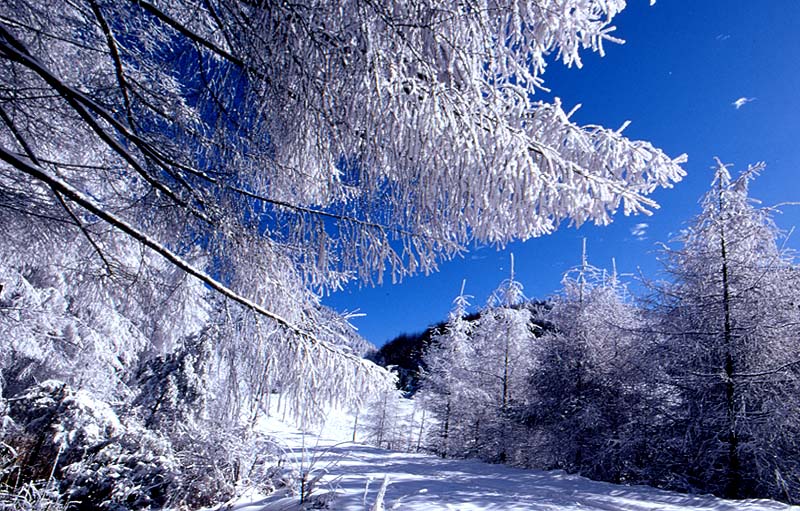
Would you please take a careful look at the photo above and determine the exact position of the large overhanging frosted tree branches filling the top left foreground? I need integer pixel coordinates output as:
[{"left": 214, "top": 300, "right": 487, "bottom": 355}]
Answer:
[{"left": 0, "top": 0, "right": 683, "bottom": 404}]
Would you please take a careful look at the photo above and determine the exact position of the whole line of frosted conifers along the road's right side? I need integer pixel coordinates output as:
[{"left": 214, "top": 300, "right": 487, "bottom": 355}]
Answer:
[{"left": 376, "top": 163, "right": 800, "bottom": 502}]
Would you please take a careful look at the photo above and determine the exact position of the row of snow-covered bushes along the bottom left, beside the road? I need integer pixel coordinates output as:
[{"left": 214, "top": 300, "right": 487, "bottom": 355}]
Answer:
[{"left": 1, "top": 380, "right": 290, "bottom": 511}]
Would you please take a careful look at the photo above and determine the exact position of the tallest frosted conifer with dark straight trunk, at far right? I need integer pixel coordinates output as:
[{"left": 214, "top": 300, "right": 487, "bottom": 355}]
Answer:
[{"left": 657, "top": 160, "right": 800, "bottom": 501}]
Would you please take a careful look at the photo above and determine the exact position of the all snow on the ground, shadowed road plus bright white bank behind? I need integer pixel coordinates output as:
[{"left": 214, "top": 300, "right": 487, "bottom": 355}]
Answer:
[{"left": 222, "top": 404, "right": 800, "bottom": 511}]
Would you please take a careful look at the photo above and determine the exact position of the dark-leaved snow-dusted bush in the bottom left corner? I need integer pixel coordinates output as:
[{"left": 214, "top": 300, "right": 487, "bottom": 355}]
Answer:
[{"left": 3, "top": 380, "right": 178, "bottom": 511}]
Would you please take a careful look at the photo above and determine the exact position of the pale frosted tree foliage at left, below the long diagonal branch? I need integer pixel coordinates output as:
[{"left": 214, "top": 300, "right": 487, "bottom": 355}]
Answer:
[{"left": 0, "top": 228, "right": 208, "bottom": 397}]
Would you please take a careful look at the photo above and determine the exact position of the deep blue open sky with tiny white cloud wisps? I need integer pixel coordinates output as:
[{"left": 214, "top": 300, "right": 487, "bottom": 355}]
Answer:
[{"left": 324, "top": 0, "right": 800, "bottom": 345}]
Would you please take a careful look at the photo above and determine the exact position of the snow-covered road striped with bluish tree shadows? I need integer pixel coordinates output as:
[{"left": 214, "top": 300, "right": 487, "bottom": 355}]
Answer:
[{"left": 280, "top": 444, "right": 788, "bottom": 511}]
